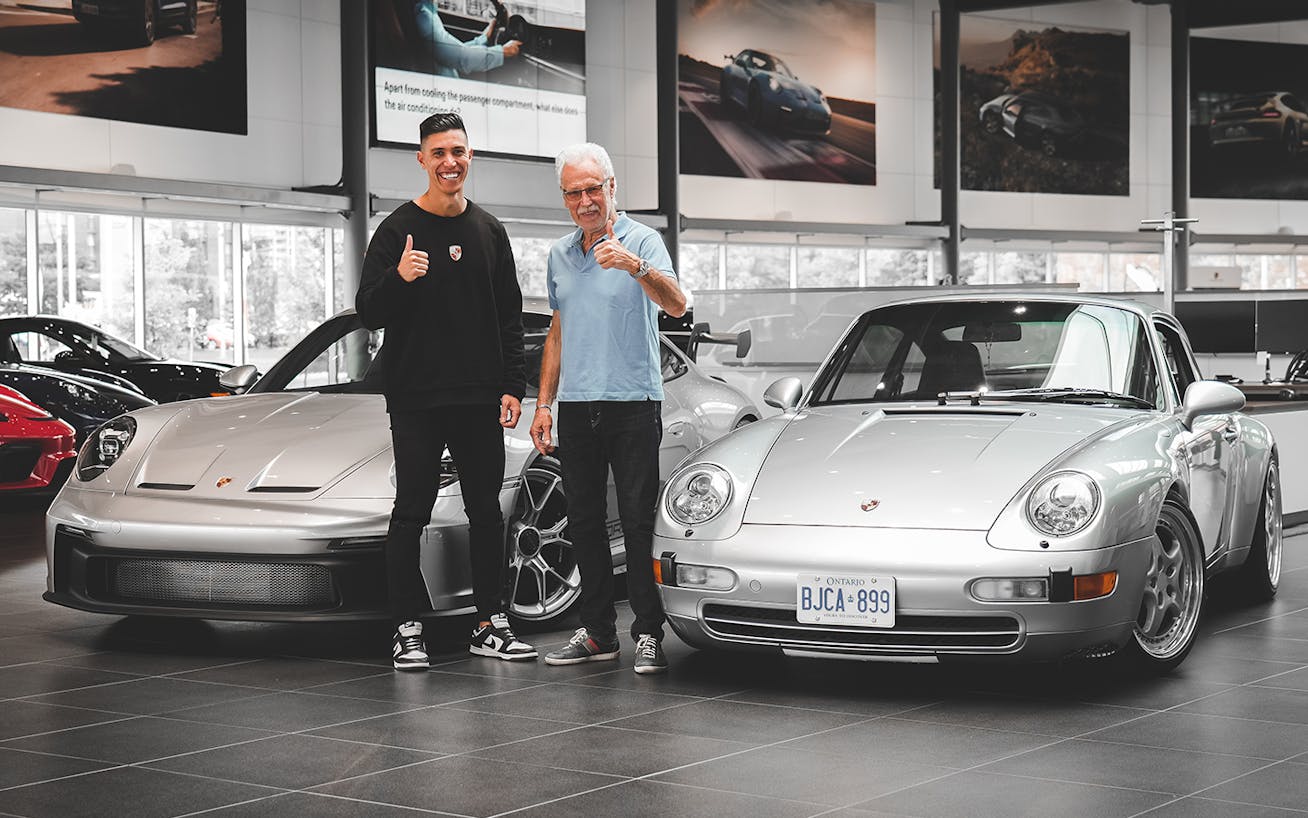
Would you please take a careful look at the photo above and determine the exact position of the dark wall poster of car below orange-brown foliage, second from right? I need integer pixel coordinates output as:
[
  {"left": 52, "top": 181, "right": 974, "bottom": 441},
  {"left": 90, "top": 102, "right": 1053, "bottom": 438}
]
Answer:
[{"left": 935, "top": 14, "right": 1130, "bottom": 196}]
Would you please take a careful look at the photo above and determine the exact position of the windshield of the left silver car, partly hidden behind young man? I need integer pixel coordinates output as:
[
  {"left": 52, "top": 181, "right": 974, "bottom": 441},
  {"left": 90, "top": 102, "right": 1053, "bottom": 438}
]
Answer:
[{"left": 250, "top": 313, "right": 549, "bottom": 398}]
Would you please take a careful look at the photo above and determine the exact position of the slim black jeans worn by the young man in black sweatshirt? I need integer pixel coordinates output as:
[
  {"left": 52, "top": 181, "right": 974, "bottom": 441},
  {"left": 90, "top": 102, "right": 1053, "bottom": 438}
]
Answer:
[{"left": 386, "top": 403, "right": 506, "bottom": 624}]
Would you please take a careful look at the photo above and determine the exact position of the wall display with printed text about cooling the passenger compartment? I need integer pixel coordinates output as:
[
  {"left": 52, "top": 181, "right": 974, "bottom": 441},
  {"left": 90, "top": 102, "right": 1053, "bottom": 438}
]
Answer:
[{"left": 369, "top": 0, "right": 586, "bottom": 158}]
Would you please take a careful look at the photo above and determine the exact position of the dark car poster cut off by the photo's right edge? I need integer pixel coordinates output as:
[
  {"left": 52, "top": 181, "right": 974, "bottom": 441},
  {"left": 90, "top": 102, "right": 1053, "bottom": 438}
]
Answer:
[{"left": 1190, "top": 37, "right": 1308, "bottom": 199}]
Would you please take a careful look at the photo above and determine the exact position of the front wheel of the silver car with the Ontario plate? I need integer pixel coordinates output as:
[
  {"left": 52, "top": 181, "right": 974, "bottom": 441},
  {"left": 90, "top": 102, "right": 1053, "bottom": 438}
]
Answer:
[{"left": 1120, "top": 497, "right": 1205, "bottom": 675}]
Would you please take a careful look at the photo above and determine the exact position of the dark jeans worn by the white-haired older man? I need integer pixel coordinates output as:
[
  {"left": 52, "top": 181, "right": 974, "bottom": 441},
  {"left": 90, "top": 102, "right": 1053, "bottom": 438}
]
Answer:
[{"left": 556, "top": 400, "right": 663, "bottom": 643}]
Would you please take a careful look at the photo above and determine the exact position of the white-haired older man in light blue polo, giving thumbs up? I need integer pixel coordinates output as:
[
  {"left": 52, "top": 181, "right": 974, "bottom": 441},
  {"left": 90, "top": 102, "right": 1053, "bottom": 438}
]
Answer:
[{"left": 531, "top": 143, "right": 685, "bottom": 673}]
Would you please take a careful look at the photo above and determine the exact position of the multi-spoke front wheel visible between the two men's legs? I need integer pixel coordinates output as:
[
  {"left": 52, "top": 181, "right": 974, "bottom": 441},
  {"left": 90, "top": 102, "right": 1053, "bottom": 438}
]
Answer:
[{"left": 506, "top": 457, "right": 581, "bottom": 624}]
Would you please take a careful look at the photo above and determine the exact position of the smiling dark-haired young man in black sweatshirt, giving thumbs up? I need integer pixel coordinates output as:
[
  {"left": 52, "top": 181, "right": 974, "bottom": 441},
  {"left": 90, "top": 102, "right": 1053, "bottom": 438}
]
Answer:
[{"left": 354, "top": 114, "right": 536, "bottom": 670}]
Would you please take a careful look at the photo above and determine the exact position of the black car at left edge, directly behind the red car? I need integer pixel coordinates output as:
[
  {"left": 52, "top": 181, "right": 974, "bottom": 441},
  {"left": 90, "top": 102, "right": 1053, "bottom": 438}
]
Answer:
[{"left": 0, "top": 364, "right": 154, "bottom": 446}]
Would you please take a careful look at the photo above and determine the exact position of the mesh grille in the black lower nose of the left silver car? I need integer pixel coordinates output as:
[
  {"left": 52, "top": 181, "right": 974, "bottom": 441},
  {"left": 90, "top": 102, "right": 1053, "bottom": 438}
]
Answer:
[{"left": 107, "top": 558, "right": 336, "bottom": 607}]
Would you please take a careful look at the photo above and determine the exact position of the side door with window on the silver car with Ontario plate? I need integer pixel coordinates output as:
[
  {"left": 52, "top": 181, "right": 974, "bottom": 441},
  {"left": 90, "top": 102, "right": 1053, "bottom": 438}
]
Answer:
[{"left": 1154, "top": 319, "right": 1243, "bottom": 558}]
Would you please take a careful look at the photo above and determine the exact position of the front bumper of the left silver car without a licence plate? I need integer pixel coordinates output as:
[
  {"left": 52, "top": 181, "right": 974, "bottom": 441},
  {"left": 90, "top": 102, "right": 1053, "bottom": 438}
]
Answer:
[{"left": 44, "top": 483, "right": 517, "bottom": 622}]
